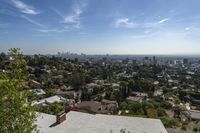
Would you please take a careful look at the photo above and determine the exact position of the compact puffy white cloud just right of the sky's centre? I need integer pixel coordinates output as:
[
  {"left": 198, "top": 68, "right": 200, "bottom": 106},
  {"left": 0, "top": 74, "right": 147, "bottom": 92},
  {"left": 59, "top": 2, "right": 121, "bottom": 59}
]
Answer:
[{"left": 114, "top": 18, "right": 137, "bottom": 28}]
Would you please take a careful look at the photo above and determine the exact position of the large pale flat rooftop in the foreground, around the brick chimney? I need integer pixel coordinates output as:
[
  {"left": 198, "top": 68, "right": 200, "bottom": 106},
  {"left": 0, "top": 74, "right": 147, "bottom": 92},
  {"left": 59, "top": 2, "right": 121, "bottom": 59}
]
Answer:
[{"left": 36, "top": 111, "right": 167, "bottom": 133}]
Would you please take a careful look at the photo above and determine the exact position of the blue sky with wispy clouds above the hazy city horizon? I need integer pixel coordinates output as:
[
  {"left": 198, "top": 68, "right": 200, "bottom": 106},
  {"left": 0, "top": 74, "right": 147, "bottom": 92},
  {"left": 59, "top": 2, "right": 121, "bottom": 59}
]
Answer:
[{"left": 0, "top": 0, "right": 200, "bottom": 54}]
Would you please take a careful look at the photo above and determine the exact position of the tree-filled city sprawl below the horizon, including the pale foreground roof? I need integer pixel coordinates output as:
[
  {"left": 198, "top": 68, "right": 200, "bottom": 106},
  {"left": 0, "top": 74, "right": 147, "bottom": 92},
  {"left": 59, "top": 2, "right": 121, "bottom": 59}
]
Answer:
[{"left": 0, "top": 50, "right": 200, "bottom": 133}]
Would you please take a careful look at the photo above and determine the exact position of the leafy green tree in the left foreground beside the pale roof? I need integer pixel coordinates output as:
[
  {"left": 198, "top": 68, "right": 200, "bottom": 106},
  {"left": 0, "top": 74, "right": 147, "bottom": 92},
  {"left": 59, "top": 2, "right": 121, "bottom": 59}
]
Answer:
[{"left": 0, "top": 49, "right": 36, "bottom": 133}]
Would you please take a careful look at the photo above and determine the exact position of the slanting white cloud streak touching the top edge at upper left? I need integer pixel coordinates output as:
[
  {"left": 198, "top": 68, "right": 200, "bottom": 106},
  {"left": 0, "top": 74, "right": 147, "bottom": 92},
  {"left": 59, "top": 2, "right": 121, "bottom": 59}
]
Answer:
[{"left": 11, "top": 0, "right": 39, "bottom": 15}]
